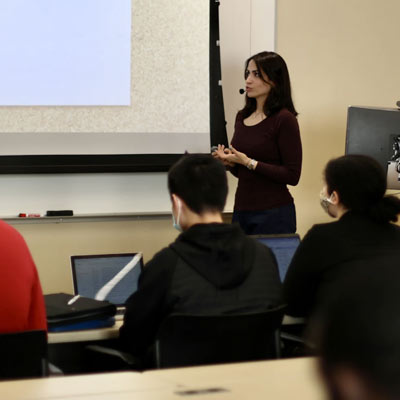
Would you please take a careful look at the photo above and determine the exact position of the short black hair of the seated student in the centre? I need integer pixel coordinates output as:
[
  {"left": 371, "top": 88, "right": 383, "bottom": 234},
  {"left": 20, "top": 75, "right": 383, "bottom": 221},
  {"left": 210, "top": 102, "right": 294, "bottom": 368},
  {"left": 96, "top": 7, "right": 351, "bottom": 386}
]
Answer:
[{"left": 168, "top": 154, "right": 228, "bottom": 214}]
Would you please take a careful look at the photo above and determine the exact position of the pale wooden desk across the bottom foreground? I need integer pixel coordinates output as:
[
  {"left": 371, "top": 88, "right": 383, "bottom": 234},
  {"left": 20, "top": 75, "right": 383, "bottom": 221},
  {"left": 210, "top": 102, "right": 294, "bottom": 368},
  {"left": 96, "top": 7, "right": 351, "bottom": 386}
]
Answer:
[{"left": 0, "top": 358, "right": 327, "bottom": 400}]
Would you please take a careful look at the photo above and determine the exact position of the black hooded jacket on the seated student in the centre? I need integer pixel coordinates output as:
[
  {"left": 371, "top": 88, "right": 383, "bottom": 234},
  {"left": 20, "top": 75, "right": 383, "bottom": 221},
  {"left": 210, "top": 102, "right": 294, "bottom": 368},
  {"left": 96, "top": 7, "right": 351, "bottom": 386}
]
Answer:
[{"left": 120, "top": 224, "right": 282, "bottom": 356}]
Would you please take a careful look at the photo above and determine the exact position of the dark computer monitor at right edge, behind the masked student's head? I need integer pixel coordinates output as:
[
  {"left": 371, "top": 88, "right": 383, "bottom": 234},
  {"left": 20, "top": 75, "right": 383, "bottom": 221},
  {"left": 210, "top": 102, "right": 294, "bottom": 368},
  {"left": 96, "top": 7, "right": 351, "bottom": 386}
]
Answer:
[{"left": 345, "top": 106, "right": 400, "bottom": 190}]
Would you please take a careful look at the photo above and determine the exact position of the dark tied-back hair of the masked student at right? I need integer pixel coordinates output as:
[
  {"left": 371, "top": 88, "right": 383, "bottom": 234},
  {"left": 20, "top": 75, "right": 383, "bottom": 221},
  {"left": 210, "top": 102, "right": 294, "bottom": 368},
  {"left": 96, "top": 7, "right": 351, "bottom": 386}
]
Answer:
[{"left": 324, "top": 155, "right": 400, "bottom": 223}]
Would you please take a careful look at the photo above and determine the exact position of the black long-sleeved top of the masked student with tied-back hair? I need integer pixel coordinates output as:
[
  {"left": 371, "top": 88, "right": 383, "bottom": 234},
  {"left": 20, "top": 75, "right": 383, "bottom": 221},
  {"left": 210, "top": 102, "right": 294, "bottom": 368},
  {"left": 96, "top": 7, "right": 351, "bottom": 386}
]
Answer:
[{"left": 284, "top": 211, "right": 400, "bottom": 317}]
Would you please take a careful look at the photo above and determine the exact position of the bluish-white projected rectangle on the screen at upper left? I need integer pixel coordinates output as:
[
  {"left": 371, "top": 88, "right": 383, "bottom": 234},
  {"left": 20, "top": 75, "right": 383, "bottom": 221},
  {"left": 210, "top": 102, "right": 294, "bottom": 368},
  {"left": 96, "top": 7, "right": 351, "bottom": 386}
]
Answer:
[{"left": 0, "top": 0, "right": 131, "bottom": 106}]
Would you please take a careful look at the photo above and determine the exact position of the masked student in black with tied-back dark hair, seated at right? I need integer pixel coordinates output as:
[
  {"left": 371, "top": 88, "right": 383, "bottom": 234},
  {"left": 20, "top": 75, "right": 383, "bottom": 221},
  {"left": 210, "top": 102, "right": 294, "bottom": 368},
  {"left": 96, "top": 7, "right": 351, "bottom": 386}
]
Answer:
[{"left": 284, "top": 155, "right": 400, "bottom": 317}]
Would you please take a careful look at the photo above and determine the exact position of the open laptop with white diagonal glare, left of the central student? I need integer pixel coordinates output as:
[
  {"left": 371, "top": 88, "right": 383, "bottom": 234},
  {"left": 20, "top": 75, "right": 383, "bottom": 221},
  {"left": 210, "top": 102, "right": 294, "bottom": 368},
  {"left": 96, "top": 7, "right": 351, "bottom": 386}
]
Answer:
[{"left": 71, "top": 253, "right": 143, "bottom": 315}]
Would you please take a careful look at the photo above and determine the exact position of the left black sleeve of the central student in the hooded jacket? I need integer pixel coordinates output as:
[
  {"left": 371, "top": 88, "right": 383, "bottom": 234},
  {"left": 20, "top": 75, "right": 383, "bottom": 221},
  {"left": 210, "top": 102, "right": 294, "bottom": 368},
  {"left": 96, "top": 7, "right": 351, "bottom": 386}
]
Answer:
[{"left": 119, "top": 248, "right": 176, "bottom": 356}]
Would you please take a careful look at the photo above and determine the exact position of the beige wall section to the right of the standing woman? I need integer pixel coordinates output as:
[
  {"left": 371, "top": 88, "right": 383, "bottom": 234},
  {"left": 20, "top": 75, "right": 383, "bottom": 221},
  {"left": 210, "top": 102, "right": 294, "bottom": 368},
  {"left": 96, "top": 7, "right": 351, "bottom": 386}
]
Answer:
[{"left": 277, "top": 0, "right": 400, "bottom": 234}]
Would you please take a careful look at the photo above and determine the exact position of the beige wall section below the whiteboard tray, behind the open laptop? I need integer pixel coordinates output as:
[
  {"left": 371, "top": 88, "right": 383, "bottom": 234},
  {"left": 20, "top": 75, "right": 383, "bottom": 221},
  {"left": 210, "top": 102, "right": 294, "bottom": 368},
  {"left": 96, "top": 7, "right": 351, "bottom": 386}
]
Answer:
[{"left": 14, "top": 215, "right": 177, "bottom": 293}]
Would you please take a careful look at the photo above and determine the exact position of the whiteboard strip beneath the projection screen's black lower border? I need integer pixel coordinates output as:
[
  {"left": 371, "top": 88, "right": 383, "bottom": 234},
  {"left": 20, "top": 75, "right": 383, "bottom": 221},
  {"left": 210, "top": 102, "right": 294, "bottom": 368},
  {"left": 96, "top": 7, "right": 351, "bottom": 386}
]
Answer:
[{"left": 0, "top": 173, "right": 171, "bottom": 217}]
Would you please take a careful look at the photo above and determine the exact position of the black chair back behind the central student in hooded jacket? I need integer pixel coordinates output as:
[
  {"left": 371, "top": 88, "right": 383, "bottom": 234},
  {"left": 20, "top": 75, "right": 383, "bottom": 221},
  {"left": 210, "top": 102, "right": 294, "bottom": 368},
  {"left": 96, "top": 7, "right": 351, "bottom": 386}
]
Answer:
[{"left": 155, "top": 306, "right": 285, "bottom": 368}]
